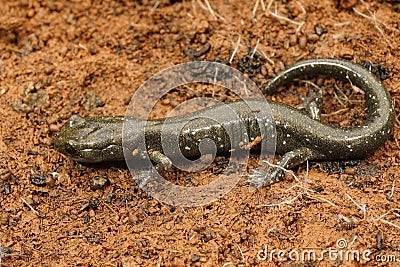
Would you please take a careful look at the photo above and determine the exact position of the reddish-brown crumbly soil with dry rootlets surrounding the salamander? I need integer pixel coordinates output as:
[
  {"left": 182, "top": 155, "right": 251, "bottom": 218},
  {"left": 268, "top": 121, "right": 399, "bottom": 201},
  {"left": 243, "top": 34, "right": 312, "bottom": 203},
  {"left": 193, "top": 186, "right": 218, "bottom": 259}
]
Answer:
[{"left": 0, "top": 0, "right": 400, "bottom": 266}]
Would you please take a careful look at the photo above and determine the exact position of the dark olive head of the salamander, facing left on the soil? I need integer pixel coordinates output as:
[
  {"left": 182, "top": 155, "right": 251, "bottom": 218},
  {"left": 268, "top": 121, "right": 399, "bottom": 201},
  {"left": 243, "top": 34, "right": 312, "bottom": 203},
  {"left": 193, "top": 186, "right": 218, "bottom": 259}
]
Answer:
[{"left": 54, "top": 115, "right": 124, "bottom": 163}]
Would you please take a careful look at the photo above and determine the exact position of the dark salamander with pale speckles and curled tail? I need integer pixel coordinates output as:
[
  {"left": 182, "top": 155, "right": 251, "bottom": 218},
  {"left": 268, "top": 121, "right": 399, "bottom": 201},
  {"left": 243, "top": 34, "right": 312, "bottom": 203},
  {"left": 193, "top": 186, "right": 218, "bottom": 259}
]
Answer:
[{"left": 54, "top": 58, "right": 394, "bottom": 185}]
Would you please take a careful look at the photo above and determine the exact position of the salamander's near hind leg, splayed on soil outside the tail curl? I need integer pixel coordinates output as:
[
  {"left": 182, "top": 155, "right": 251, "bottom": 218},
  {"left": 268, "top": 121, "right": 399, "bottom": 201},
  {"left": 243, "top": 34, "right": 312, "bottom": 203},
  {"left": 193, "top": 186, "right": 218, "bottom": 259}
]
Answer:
[{"left": 249, "top": 147, "right": 314, "bottom": 187}]
